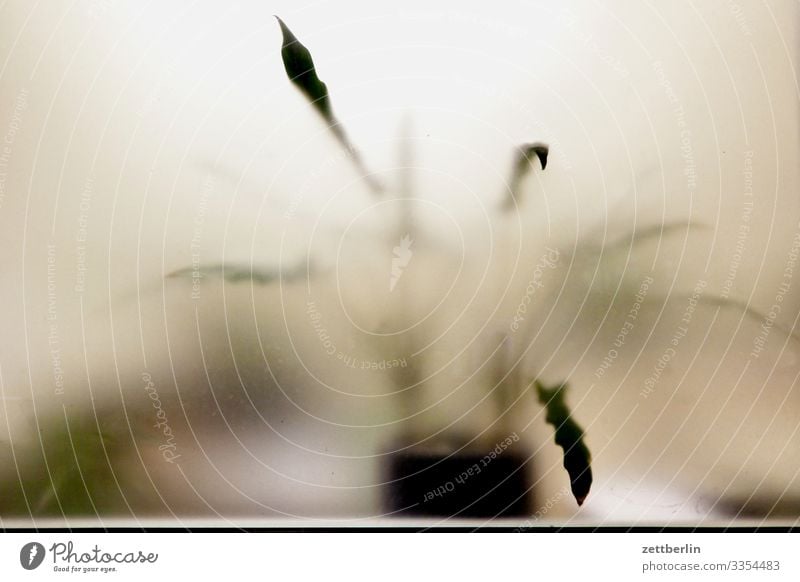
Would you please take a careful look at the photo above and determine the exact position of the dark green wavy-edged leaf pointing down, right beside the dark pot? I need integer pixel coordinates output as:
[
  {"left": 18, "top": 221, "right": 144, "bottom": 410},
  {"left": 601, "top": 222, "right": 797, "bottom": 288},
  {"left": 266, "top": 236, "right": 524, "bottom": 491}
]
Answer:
[{"left": 535, "top": 380, "right": 592, "bottom": 505}]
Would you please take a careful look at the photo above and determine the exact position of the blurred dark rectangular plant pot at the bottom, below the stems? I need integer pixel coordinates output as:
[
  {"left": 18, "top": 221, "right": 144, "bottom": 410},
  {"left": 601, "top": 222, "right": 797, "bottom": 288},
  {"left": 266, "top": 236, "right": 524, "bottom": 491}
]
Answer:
[{"left": 385, "top": 451, "right": 534, "bottom": 518}]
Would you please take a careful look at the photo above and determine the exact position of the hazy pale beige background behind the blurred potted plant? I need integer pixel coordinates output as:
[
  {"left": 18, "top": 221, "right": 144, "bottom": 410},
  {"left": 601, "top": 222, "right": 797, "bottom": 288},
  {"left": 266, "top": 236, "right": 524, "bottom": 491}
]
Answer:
[{"left": 0, "top": 0, "right": 800, "bottom": 523}]
